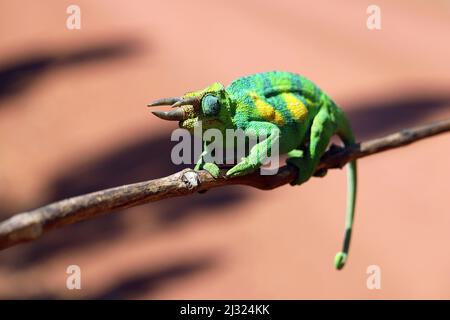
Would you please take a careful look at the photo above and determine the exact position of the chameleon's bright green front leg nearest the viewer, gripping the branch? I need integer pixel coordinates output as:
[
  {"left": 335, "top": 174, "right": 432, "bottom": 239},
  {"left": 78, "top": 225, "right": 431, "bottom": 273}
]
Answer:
[{"left": 226, "top": 121, "right": 280, "bottom": 177}]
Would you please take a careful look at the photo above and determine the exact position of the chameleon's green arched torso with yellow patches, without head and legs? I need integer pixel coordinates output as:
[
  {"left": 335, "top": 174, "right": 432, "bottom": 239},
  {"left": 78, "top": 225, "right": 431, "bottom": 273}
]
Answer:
[{"left": 226, "top": 71, "right": 323, "bottom": 153}]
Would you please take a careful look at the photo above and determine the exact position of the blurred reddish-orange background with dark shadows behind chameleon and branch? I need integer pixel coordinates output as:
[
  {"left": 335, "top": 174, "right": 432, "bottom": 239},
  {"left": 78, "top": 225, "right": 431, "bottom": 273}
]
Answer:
[{"left": 0, "top": 0, "right": 450, "bottom": 299}]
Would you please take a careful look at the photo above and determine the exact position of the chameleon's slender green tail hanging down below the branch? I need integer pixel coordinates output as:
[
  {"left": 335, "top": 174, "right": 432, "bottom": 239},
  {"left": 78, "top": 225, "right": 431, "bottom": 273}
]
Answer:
[{"left": 334, "top": 109, "right": 357, "bottom": 270}]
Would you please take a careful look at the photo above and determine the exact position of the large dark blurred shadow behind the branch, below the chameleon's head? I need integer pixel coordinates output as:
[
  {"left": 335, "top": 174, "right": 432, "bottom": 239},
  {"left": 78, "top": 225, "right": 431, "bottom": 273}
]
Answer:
[{"left": 0, "top": 132, "right": 249, "bottom": 269}]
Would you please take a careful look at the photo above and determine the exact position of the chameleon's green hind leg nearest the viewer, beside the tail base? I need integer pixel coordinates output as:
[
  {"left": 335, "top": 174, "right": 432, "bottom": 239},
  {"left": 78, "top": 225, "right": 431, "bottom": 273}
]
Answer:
[{"left": 286, "top": 108, "right": 336, "bottom": 185}]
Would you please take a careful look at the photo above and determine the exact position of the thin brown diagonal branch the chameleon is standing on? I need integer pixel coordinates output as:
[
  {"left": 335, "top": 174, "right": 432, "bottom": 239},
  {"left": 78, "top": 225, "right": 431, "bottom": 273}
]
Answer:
[{"left": 0, "top": 119, "right": 450, "bottom": 250}]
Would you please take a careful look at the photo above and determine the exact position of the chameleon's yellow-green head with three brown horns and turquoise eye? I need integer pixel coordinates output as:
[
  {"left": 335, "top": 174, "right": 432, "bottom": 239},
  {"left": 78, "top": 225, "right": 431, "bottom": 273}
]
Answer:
[{"left": 148, "top": 83, "right": 233, "bottom": 133}]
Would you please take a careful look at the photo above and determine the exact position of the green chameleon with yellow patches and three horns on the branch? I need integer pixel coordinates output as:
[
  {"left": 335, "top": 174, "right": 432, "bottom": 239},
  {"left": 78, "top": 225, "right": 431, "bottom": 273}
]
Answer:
[{"left": 148, "top": 71, "right": 356, "bottom": 269}]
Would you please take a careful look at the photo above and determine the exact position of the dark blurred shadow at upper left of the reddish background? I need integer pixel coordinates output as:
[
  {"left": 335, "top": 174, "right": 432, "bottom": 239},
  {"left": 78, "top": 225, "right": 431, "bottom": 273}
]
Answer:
[{"left": 0, "top": 39, "right": 141, "bottom": 99}]
